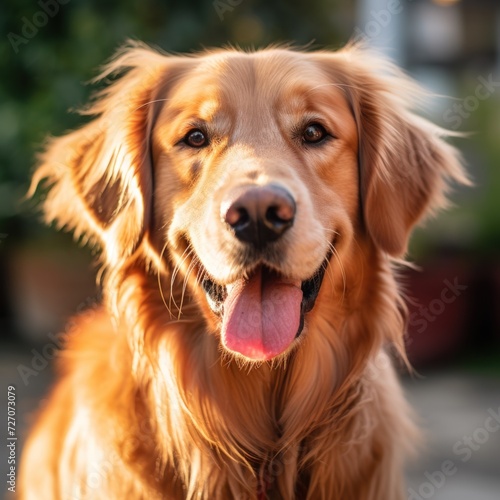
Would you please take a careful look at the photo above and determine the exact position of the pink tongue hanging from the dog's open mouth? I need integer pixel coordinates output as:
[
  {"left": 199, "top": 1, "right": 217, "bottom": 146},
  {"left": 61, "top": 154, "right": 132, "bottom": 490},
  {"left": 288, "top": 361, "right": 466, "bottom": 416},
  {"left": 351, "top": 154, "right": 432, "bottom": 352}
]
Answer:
[{"left": 222, "top": 269, "right": 302, "bottom": 360}]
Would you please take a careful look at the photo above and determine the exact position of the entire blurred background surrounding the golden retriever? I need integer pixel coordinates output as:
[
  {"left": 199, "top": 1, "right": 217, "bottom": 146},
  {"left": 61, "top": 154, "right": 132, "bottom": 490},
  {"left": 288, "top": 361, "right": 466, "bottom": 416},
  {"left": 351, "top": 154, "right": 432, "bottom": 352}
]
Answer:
[{"left": 0, "top": 0, "right": 500, "bottom": 500}]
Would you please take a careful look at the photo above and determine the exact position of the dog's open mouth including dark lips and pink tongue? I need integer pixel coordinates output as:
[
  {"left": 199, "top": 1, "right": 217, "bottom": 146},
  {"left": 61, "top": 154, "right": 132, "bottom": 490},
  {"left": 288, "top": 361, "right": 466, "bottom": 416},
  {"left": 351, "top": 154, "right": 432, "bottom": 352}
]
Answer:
[{"left": 202, "top": 253, "right": 331, "bottom": 361}]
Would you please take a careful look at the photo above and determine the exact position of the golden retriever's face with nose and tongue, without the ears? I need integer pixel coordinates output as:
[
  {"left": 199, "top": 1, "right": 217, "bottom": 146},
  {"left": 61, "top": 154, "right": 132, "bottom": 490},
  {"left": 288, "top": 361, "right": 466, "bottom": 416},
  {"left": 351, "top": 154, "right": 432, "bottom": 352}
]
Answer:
[{"left": 153, "top": 51, "right": 359, "bottom": 360}]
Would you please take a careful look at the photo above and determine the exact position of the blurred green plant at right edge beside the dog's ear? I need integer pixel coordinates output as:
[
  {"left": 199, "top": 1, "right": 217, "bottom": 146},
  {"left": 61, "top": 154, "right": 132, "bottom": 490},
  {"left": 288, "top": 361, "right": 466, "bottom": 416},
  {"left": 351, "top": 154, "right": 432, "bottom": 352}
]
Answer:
[{"left": 412, "top": 69, "right": 500, "bottom": 259}]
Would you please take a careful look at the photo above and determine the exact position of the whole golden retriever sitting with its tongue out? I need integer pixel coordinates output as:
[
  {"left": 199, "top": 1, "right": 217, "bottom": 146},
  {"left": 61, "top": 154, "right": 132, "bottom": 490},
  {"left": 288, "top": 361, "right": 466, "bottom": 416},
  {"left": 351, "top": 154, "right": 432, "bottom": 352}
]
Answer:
[{"left": 20, "top": 43, "right": 468, "bottom": 500}]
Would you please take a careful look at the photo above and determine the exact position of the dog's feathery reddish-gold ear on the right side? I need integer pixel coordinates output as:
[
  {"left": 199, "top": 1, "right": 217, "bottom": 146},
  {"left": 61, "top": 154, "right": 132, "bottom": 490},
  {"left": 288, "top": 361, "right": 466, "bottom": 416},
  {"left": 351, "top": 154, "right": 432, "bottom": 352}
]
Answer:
[{"left": 316, "top": 46, "right": 470, "bottom": 256}]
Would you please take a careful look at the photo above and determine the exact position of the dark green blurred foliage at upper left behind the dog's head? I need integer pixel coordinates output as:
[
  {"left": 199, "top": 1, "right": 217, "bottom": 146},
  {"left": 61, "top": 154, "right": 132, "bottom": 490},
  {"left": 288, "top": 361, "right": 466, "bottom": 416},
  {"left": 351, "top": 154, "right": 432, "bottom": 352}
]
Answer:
[{"left": 0, "top": 0, "right": 348, "bottom": 232}]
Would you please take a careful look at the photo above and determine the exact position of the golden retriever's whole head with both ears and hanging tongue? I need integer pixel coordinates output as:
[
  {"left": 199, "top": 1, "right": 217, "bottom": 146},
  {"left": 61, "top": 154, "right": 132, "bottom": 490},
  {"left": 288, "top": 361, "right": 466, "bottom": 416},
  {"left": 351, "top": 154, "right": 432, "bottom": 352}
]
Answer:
[{"left": 35, "top": 46, "right": 466, "bottom": 360}]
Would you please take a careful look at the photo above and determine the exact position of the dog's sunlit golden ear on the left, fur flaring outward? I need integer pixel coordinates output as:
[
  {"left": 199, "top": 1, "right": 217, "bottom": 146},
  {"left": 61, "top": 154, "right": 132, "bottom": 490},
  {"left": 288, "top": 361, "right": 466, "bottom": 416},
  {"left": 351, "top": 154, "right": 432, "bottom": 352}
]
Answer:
[{"left": 31, "top": 44, "right": 183, "bottom": 263}]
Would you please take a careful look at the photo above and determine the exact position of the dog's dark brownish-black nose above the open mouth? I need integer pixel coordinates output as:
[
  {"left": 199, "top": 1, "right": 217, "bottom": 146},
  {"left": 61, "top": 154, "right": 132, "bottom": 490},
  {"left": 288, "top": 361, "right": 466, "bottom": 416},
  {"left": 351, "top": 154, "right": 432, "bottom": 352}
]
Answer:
[{"left": 221, "top": 184, "right": 295, "bottom": 247}]
